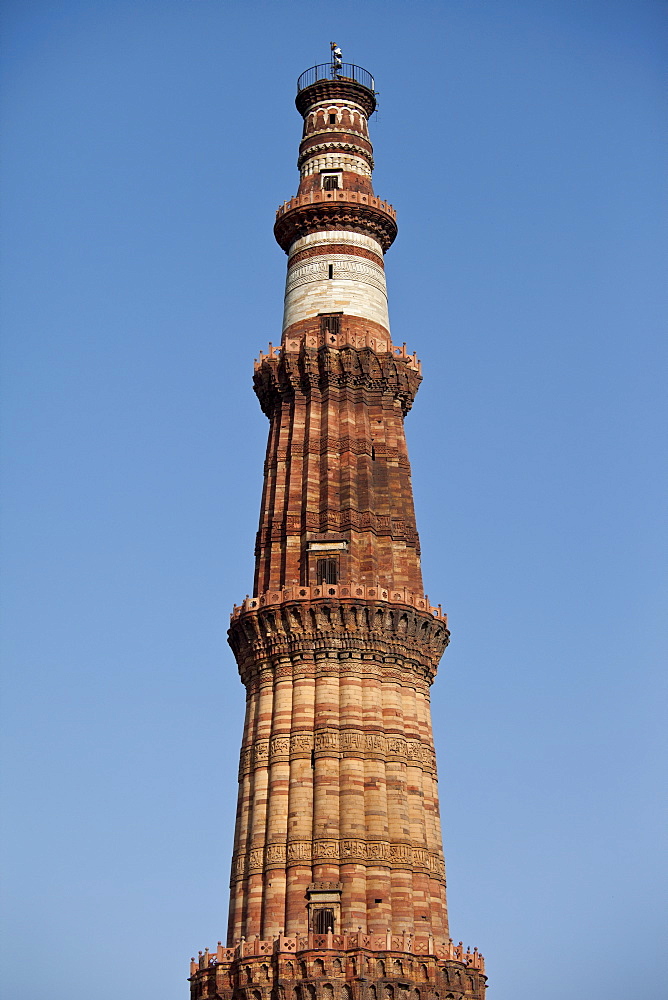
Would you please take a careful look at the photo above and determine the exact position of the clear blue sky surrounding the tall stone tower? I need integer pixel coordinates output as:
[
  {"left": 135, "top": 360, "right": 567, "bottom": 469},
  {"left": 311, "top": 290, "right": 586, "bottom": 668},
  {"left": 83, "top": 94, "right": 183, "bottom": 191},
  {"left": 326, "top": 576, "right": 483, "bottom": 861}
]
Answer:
[{"left": 2, "top": 0, "right": 668, "bottom": 1000}]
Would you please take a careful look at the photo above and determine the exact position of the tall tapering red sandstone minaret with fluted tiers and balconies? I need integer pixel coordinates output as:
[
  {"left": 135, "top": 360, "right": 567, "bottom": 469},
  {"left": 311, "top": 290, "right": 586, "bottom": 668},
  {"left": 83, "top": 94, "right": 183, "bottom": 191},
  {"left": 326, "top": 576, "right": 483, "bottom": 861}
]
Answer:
[{"left": 190, "top": 43, "right": 485, "bottom": 1000}]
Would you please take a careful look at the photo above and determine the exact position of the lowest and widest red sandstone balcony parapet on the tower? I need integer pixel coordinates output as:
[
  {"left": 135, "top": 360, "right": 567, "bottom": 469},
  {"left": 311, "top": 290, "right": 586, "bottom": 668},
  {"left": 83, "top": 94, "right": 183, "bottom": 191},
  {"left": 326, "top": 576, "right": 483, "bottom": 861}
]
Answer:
[{"left": 190, "top": 931, "right": 485, "bottom": 976}]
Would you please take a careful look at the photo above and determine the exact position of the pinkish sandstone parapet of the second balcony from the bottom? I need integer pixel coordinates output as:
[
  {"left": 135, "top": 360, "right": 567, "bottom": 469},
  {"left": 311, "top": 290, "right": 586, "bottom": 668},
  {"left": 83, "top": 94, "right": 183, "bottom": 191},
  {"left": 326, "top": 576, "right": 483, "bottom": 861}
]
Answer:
[{"left": 230, "top": 583, "right": 448, "bottom": 627}]
